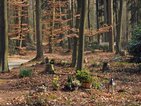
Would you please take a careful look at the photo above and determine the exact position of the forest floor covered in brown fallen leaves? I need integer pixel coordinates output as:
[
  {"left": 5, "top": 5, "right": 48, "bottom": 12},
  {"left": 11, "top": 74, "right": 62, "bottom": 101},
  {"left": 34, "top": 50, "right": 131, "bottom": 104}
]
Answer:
[{"left": 0, "top": 49, "right": 141, "bottom": 106}]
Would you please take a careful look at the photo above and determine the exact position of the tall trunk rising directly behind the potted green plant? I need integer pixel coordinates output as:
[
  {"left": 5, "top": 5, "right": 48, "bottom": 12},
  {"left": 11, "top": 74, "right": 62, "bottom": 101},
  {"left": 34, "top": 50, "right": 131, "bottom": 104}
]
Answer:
[{"left": 77, "top": 0, "right": 87, "bottom": 70}]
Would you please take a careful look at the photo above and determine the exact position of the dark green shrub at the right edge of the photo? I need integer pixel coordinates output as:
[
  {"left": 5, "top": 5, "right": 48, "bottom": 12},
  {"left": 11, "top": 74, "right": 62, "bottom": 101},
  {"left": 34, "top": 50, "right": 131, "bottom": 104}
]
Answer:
[{"left": 128, "top": 25, "right": 141, "bottom": 59}]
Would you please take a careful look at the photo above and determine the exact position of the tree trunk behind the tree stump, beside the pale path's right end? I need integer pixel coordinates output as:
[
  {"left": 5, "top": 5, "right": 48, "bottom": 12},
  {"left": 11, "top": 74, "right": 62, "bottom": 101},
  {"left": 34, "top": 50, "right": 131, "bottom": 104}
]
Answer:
[{"left": 36, "top": 0, "right": 43, "bottom": 59}]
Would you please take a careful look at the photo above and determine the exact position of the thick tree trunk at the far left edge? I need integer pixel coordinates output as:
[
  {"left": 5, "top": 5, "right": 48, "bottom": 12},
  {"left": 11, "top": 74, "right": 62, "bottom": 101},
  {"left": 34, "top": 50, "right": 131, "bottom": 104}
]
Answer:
[{"left": 0, "top": 0, "right": 9, "bottom": 72}]
